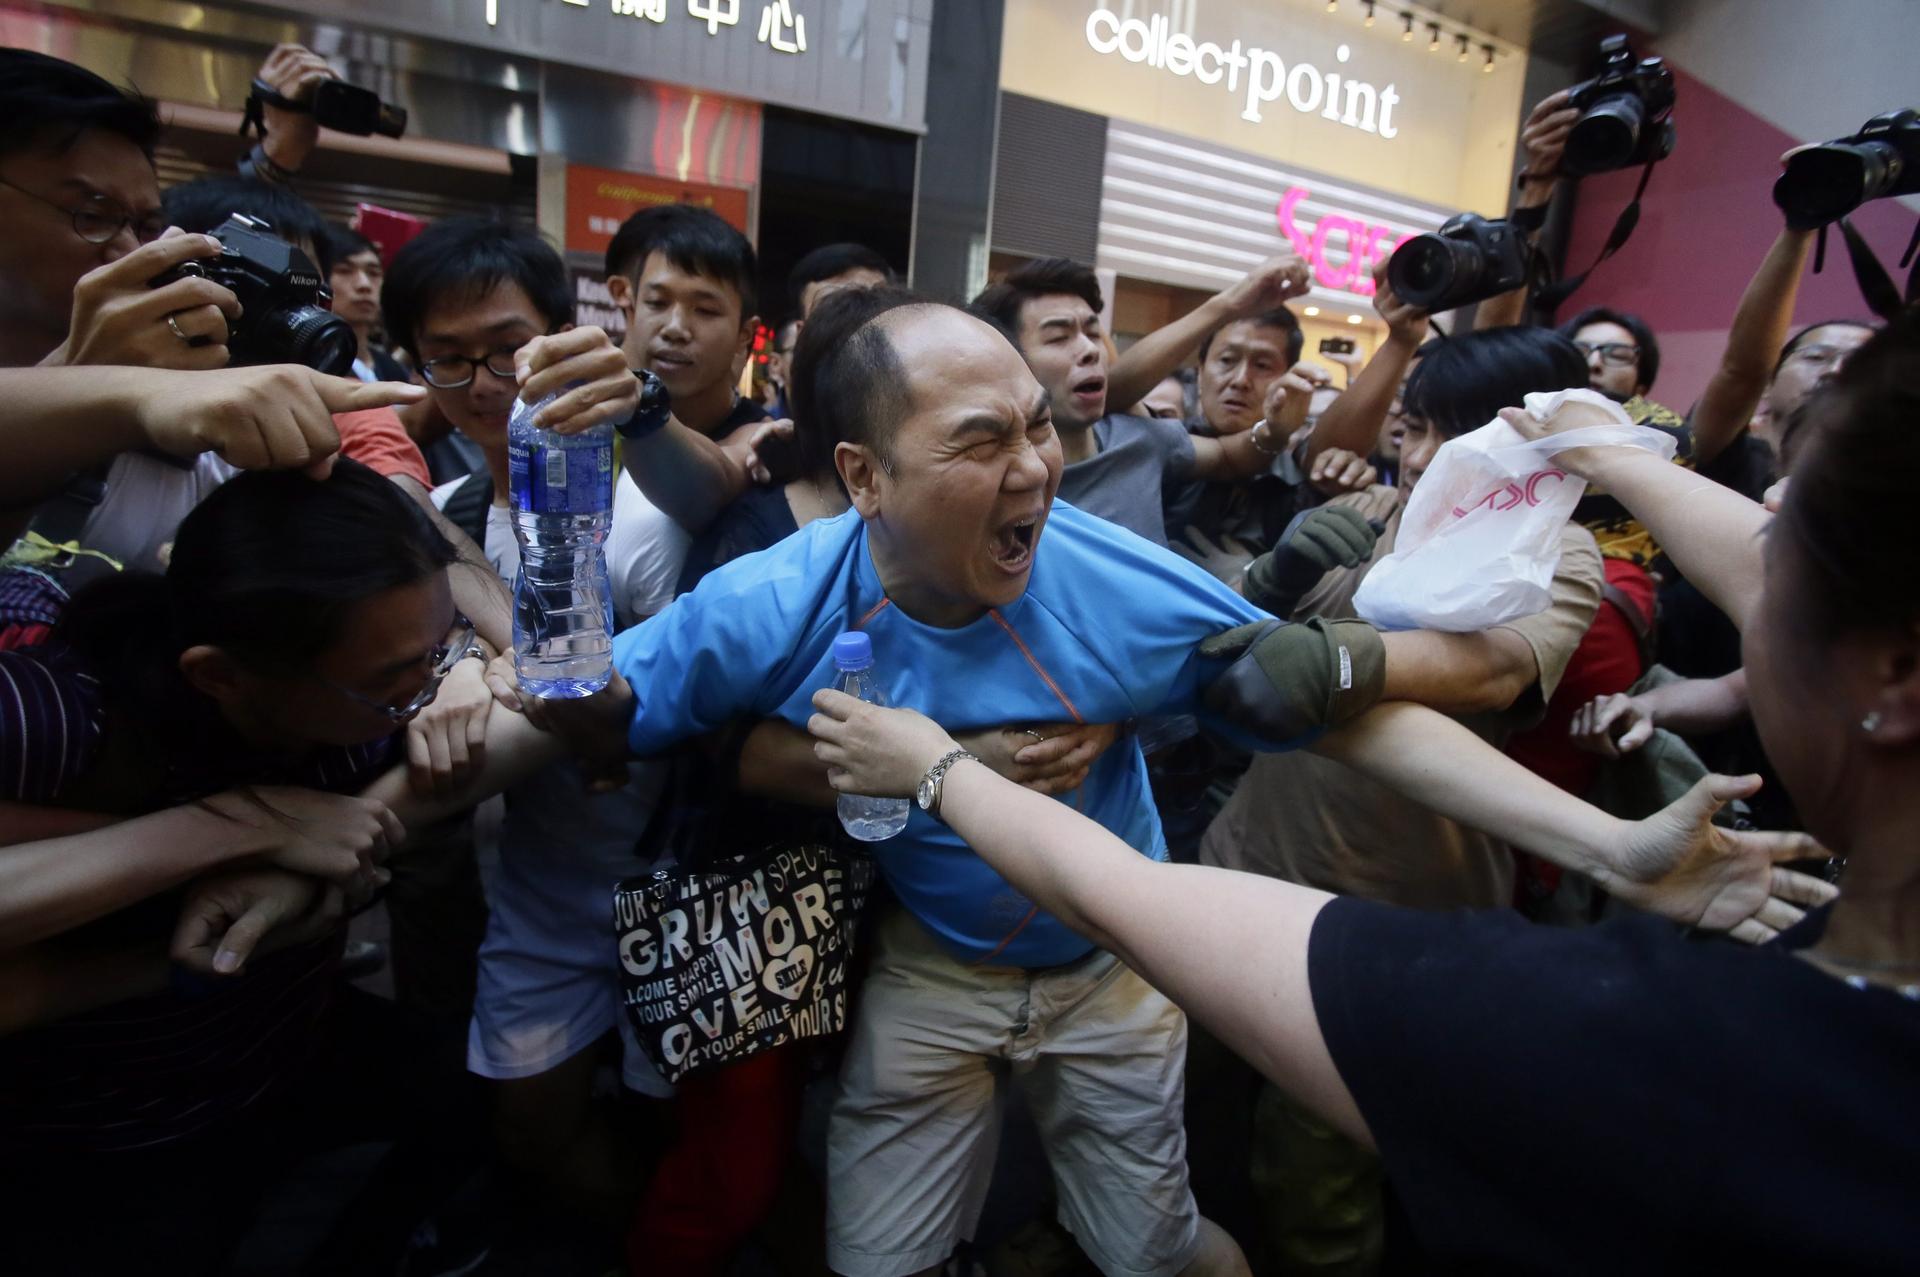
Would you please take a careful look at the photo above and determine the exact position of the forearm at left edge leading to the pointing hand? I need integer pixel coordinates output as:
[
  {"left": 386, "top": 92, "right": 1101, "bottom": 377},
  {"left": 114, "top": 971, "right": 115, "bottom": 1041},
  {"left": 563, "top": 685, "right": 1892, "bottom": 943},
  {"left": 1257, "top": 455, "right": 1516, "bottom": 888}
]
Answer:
[{"left": 0, "top": 367, "right": 156, "bottom": 509}]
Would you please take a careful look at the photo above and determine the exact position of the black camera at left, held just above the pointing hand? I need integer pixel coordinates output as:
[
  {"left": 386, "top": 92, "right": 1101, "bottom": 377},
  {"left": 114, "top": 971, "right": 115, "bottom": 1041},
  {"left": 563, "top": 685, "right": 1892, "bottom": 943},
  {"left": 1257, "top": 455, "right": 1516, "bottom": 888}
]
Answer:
[{"left": 154, "top": 213, "right": 359, "bottom": 376}]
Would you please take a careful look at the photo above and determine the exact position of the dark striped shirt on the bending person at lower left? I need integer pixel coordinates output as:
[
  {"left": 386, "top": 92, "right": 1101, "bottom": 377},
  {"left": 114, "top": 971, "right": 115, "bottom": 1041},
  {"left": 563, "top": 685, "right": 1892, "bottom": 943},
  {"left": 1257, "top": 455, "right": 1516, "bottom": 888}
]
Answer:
[{"left": 0, "top": 576, "right": 396, "bottom": 1152}]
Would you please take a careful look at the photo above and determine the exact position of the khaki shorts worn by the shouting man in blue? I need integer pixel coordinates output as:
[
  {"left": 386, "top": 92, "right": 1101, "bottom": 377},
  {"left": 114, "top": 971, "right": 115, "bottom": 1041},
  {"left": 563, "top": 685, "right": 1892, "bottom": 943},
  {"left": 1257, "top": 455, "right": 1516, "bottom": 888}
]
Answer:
[{"left": 828, "top": 912, "right": 1200, "bottom": 1277}]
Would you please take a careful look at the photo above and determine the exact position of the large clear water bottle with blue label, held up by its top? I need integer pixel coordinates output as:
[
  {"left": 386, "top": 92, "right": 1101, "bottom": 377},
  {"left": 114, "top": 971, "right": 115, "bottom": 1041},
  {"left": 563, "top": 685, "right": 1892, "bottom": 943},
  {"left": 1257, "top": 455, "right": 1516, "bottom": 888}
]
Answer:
[{"left": 507, "top": 396, "right": 614, "bottom": 699}]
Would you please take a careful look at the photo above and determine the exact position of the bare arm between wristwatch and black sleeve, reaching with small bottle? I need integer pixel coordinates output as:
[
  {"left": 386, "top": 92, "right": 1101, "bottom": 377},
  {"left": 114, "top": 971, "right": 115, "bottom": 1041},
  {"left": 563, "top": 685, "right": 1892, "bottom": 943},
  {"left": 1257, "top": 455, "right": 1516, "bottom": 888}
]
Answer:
[{"left": 941, "top": 762, "right": 1371, "bottom": 1143}]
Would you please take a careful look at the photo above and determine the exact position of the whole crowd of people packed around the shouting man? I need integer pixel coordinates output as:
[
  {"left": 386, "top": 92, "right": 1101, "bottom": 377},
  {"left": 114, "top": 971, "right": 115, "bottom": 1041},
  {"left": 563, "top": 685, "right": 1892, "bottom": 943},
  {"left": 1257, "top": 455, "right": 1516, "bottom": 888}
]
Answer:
[{"left": 0, "top": 37, "right": 1920, "bottom": 1277}]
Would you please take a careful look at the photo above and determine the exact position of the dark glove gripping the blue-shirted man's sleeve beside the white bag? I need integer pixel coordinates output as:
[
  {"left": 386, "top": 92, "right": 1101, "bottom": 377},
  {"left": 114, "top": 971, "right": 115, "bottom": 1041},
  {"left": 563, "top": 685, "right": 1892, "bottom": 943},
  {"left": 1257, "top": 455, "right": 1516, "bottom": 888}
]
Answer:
[{"left": 1200, "top": 618, "right": 1386, "bottom": 745}]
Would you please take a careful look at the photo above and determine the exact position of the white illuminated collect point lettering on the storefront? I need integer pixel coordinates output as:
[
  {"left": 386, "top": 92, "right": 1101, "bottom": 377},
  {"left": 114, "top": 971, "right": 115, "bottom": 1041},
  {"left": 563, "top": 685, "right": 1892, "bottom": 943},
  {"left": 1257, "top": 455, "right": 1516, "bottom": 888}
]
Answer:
[{"left": 1087, "top": 10, "right": 1400, "bottom": 138}]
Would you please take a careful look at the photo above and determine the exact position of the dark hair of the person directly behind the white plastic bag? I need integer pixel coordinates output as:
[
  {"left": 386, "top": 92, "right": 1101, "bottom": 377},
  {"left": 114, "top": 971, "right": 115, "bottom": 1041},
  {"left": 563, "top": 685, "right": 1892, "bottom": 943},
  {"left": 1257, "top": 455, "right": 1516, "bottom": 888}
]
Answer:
[{"left": 1400, "top": 325, "right": 1588, "bottom": 438}]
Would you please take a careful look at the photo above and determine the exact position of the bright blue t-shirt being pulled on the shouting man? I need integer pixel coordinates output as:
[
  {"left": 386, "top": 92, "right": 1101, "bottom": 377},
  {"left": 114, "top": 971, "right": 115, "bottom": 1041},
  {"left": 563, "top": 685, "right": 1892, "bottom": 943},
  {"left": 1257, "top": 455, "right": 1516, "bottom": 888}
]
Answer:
[{"left": 612, "top": 501, "right": 1273, "bottom": 966}]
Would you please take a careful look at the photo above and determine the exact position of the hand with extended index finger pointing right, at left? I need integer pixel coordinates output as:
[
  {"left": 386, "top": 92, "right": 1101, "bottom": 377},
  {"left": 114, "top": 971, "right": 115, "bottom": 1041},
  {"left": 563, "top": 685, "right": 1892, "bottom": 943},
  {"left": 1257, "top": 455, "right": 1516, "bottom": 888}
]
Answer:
[{"left": 134, "top": 366, "right": 426, "bottom": 478}]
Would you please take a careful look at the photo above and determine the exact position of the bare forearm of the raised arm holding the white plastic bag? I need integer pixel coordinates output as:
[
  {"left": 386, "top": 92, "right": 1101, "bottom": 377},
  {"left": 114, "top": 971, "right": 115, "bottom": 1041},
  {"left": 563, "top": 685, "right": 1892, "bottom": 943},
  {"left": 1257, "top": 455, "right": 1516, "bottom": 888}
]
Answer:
[{"left": 1559, "top": 447, "right": 1768, "bottom": 630}]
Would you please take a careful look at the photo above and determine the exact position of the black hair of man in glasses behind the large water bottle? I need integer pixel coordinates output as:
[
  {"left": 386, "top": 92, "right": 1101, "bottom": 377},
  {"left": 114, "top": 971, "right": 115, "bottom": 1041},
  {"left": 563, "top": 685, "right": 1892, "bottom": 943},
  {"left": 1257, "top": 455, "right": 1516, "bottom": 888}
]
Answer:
[{"left": 380, "top": 217, "right": 574, "bottom": 355}]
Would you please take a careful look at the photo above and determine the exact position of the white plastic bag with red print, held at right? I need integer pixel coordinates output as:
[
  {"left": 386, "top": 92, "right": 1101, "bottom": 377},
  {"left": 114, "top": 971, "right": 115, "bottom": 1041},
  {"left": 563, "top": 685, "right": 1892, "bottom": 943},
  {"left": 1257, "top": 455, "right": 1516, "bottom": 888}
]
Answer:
[{"left": 1354, "top": 390, "right": 1674, "bottom": 634}]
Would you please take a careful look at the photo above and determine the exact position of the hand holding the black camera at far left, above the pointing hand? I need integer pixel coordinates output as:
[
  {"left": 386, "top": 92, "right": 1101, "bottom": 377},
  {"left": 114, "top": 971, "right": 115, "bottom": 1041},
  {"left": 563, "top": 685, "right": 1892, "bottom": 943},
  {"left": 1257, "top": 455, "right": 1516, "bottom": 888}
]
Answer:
[{"left": 40, "top": 229, "right": 240, "bottom": 373}]
